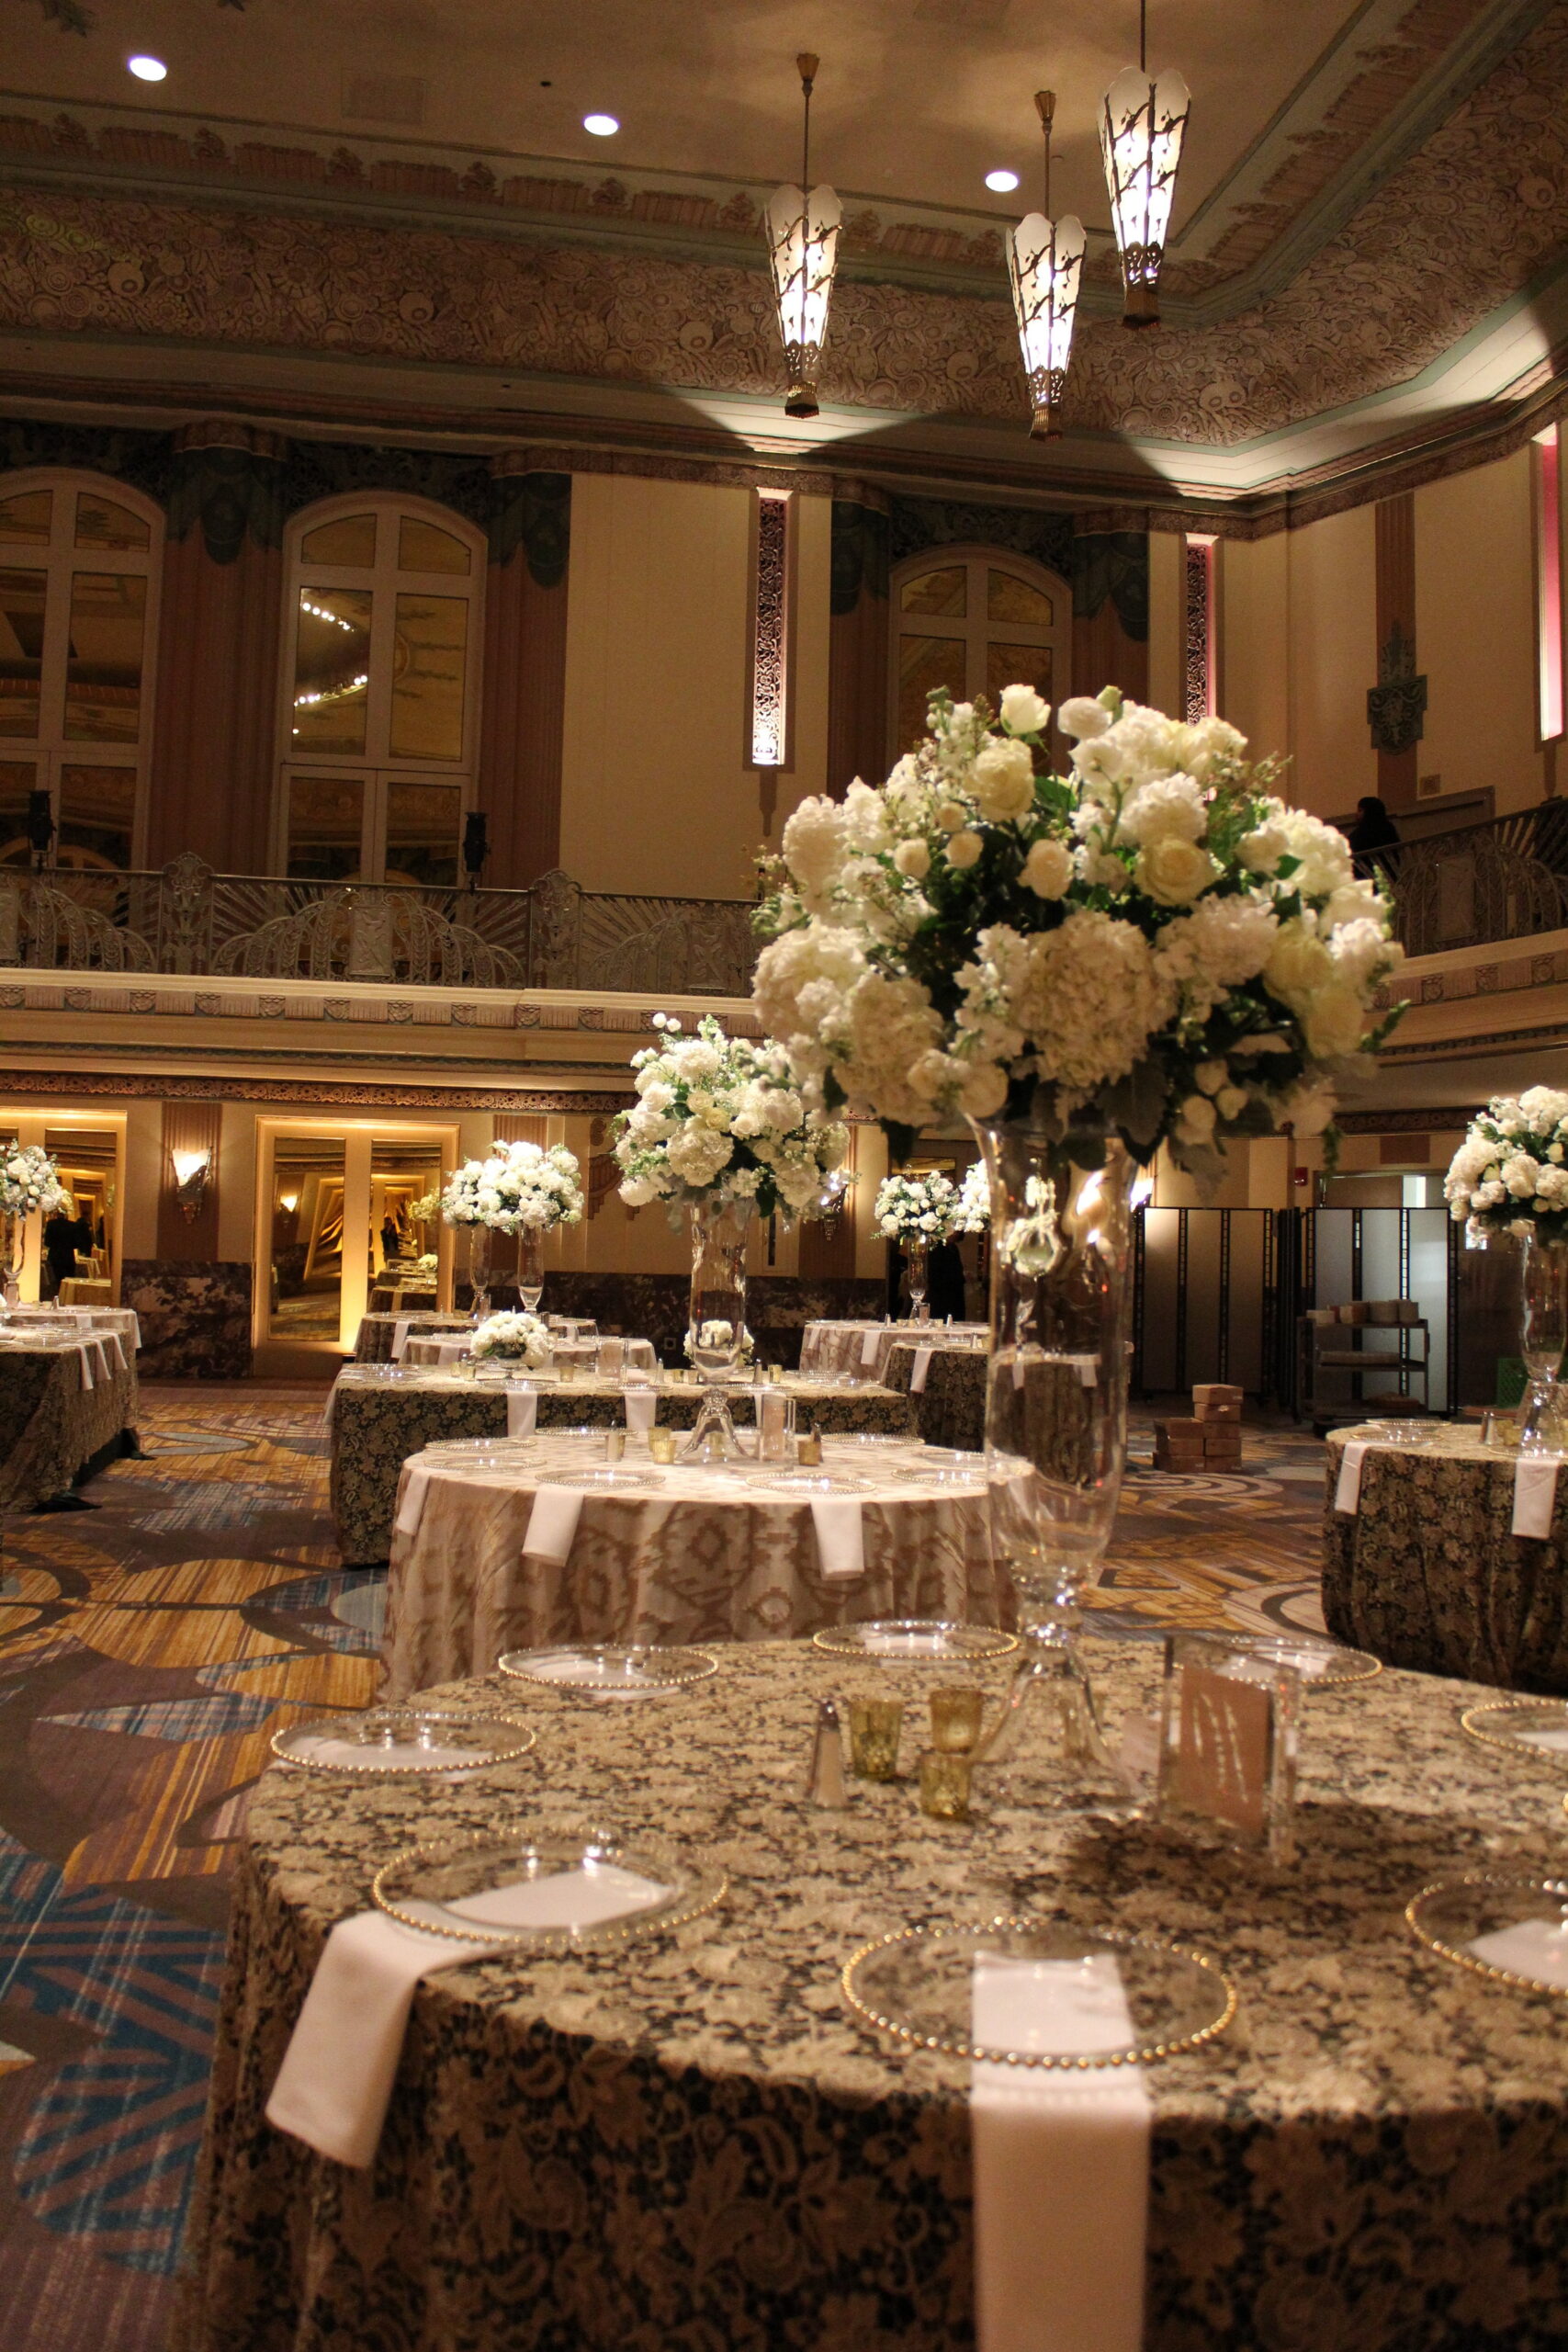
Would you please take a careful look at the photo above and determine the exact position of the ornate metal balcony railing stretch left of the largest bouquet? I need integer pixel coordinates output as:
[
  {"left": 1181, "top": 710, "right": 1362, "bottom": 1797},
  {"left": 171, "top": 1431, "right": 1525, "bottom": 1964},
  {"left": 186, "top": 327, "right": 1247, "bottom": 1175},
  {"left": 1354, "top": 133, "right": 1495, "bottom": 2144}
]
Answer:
[{"left": 0, "top": 856, "right": 757, "bottom": 997}]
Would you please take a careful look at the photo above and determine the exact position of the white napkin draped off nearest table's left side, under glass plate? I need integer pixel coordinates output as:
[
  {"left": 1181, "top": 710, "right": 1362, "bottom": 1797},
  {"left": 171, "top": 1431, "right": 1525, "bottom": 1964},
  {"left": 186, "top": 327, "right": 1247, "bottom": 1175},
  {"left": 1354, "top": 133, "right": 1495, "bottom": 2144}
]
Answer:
[{"left": 265, "top": 1865, "right": 665, "bottom": 2168}]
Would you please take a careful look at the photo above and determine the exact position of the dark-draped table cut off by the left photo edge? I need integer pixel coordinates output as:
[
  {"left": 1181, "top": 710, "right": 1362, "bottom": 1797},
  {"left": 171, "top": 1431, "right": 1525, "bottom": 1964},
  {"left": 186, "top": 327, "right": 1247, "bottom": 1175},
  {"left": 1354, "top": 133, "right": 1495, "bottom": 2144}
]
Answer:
[{"left": 0, "top": 1327, "right": 136, "bottom": 1510}]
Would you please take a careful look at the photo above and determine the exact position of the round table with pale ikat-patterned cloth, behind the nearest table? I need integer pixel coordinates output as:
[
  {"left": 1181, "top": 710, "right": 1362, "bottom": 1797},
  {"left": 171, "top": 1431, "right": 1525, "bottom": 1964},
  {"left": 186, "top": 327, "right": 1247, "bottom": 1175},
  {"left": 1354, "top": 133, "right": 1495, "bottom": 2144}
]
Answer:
[{"left": 381, "top": 1435, "right": 1013, "bottom": 1698}]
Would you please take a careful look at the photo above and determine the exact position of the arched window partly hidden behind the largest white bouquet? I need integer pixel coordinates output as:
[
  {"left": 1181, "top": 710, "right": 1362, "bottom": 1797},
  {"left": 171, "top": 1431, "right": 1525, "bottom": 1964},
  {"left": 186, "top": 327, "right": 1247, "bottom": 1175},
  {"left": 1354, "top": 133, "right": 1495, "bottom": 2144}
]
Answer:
[{"left": 891, "top": 548, "right": 1072, "bottom": 757}]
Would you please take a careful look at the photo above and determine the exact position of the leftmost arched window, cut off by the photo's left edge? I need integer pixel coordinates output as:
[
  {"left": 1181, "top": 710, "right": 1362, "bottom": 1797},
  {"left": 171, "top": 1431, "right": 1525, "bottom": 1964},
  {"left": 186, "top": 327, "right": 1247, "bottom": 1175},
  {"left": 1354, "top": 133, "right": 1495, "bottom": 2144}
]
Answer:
[{"left": 0, "top": 470, "right": 163, "bottom": 873}]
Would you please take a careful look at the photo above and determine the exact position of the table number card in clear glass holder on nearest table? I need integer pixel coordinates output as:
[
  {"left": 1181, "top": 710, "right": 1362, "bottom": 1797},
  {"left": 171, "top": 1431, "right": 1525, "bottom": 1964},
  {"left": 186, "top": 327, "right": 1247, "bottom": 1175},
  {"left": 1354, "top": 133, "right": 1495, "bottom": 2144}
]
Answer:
[{"left": 1159, "top": 1634, "right": 1300, "bottom": 1865}]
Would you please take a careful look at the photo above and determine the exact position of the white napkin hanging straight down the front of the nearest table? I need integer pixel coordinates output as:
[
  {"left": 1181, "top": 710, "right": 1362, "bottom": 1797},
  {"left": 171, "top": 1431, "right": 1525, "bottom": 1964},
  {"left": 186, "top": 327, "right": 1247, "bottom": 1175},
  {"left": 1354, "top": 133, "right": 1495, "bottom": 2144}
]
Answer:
[{"left": 968, "top": 1952, "right": 1152, "bottom": 2352}]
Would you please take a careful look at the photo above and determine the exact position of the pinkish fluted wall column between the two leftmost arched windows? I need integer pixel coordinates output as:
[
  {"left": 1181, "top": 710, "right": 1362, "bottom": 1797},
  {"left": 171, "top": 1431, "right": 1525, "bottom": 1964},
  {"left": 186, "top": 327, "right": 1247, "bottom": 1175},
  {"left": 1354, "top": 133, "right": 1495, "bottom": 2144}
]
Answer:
[{"left": 148, "top": 424, "right": 287, "bottom": 873}]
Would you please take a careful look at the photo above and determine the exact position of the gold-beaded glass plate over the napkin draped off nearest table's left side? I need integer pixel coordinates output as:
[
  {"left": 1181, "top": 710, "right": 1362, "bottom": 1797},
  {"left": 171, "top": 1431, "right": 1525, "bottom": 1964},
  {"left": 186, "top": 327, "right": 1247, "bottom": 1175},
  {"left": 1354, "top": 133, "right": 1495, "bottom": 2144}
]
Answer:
[{"left": 371, "top": 1823, "right": 727, "bottom": 1952}]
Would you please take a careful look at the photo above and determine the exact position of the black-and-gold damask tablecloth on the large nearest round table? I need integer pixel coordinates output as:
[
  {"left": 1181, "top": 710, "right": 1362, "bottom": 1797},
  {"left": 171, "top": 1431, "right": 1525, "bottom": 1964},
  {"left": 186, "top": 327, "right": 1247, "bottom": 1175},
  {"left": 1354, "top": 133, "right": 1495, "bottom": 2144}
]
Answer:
[{"left": 174, "top": 1642, "right": 1568, "bottom": 2352}]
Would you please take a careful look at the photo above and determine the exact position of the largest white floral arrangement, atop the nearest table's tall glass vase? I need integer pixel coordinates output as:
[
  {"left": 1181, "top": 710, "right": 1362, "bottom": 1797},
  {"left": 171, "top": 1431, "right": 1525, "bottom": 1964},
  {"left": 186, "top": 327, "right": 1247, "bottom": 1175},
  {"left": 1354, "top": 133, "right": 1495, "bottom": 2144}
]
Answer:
[{"left": 755, "top": 684, "right": 1401, "bottom": 1181}]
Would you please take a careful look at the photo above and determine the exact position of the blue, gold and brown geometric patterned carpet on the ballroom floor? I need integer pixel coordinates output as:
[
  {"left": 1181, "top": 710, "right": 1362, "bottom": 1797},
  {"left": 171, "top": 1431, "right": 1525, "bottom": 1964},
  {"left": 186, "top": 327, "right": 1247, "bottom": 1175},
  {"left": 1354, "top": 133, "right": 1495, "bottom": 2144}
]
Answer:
[{"left": 0, "top": 1383, "right": 1321, "bottom": 2352}]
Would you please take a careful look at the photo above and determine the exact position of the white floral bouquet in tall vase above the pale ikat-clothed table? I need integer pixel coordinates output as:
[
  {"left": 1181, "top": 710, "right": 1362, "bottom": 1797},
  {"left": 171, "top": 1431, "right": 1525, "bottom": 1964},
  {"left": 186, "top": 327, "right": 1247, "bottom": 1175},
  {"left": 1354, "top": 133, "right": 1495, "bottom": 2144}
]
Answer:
[{"left": 616, "top": 1013, "right": 849, "bottom": 1216}]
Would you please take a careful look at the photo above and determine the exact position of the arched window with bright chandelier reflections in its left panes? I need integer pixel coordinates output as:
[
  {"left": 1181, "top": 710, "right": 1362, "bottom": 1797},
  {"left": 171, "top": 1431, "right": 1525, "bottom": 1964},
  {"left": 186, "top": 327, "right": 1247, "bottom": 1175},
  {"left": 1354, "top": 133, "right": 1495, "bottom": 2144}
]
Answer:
[{"left": 277, "top": 496, "right": 484, "bottom": 889}]
